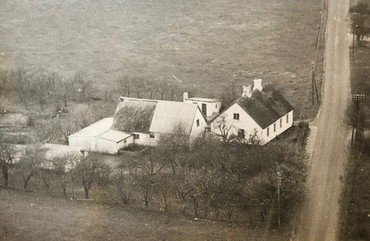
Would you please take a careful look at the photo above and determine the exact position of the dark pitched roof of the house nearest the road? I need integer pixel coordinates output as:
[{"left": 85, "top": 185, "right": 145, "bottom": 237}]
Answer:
[{"left": 236, "top": 85, "right": 294, "bottom": 129}]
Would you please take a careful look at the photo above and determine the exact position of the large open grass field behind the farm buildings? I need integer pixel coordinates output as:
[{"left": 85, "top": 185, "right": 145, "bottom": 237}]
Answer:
[{"left": 0, "top": 0, "right": 321, "bottom": 117}]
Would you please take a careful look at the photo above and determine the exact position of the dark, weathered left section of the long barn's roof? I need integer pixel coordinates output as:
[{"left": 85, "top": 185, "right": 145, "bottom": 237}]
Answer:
[{"left": 112, "top": 98, "right": 157, "bottom": 133}]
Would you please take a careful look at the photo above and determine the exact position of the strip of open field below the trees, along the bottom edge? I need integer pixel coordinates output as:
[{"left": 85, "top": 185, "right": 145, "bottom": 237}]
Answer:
[{"left": 0, "top": 189, "right": 288, "bottom": 241}]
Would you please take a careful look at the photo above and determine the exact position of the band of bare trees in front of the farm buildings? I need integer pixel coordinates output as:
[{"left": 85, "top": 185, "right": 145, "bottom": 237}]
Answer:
[{"left": 0, "top": 124, "right": 306, "bottom": 226}]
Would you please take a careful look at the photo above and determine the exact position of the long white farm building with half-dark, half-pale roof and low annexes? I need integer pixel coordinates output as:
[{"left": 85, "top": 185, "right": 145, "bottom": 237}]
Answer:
[{"left": 69, "top": 97, "right": 207, "bottom": 154}]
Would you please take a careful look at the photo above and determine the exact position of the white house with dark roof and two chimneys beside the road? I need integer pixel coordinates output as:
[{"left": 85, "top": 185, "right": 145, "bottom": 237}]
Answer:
[{"left": 210, "top": 79, "right": 293, "bottom": 145}]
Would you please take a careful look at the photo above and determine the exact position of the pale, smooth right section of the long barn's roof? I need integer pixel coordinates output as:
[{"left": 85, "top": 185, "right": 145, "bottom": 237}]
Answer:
[{"left": 150, "top": 101, "right": 198, "bottom": 134}]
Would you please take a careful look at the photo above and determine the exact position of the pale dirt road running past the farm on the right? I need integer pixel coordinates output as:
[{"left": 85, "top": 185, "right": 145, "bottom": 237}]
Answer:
[{"left": 296, "top": 0, "right": 350, "bottom": 241}]
